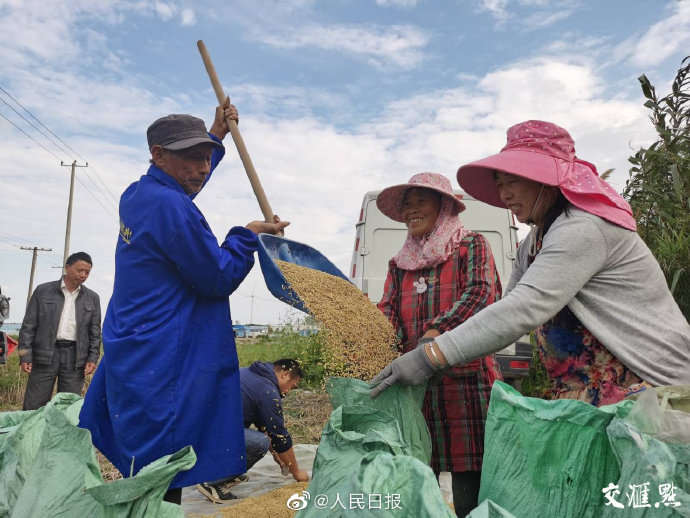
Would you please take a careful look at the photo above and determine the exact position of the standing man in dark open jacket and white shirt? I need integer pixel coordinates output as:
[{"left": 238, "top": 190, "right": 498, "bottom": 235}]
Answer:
[{"left": 19, "top": 252, "right": 101, "bottom": 410}]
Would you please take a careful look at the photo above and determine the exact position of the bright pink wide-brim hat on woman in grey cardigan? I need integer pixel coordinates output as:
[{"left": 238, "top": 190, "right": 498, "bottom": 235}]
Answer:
[{"left": 458, "top": 120, "right": 636, "bottom": 230}]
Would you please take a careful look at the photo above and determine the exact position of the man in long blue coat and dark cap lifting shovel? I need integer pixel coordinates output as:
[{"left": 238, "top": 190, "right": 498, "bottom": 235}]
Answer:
[{"left": 80, "top": 102, "right": 288, "bottom": 503}]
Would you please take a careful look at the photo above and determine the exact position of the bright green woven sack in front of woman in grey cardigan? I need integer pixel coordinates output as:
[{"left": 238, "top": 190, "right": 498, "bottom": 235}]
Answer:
[{"left": 479, "top": 382, "right": 633, "bottom": 518}]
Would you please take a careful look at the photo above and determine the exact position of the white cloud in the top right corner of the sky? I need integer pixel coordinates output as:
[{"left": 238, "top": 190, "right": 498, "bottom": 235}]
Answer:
[{"left": 628, "top": 1, "right": 690, "bottom": 67}]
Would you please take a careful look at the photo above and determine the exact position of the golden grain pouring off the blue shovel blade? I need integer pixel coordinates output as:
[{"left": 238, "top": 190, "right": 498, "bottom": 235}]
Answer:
[{"left": 276, "top": 261, "right": 398, "bottom": 380}]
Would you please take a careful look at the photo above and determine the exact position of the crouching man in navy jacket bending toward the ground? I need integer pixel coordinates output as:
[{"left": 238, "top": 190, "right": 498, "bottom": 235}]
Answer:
[{"left": 198, "top": 359, "right": 309, "bottom": 503}]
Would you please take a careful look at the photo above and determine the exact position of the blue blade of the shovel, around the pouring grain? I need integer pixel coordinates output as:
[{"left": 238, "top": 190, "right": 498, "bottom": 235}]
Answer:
[{"left": 258, "top": 234, "right": 352, "bottom": 313}]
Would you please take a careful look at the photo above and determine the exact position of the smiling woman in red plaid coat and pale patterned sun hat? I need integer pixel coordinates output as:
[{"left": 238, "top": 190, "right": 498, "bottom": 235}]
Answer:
[{"left": 376, "top": 173, "right": 501, "bottom": 516}]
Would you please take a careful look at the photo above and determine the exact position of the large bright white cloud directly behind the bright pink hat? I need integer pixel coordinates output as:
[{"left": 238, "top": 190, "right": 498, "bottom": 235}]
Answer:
[{"left": 358, "top": 57, "right": 653, "bottom": 195}]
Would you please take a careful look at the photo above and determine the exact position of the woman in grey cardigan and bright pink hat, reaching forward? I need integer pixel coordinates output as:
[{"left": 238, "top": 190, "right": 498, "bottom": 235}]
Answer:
[{"left": 375, "top": 121, "right": 690, "bottom": 406}]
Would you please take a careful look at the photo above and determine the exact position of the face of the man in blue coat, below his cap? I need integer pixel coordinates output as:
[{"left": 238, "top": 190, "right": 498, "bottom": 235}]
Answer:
[{"left": 151, "top": 144, "right": 213, "bottom": 194}]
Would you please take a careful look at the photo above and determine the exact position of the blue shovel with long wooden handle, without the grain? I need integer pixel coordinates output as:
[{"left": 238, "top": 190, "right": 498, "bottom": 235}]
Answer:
[{"left": 197, "top": 40, "right": 349, "bottom": 312}]
